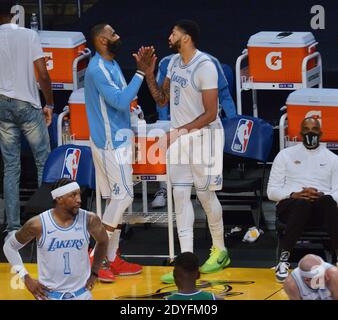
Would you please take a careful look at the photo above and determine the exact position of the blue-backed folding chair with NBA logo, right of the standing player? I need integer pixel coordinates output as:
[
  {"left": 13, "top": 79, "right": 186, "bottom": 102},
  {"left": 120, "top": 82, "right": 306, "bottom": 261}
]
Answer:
[{"left": 217, "top": 116, "right": 273, "bottom": 228}]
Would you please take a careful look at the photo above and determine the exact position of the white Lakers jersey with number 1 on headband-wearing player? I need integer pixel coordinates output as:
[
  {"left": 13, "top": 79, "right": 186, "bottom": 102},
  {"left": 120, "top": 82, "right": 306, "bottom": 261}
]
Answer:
[{"left": 37, "top": 209, "right": 90, "bottom": 292}]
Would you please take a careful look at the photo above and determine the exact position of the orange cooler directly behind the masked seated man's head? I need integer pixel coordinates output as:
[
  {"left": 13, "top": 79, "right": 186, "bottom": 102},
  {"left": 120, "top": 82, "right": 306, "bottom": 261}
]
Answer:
[{"left": 286, "top": 88, "right": 338, "bottom": 142}]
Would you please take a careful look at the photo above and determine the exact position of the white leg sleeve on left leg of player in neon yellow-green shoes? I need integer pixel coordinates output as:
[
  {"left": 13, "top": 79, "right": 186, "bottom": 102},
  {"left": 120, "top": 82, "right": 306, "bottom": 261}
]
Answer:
[{"left": 173, "top": 187, "right": 194, "bottom": 252}]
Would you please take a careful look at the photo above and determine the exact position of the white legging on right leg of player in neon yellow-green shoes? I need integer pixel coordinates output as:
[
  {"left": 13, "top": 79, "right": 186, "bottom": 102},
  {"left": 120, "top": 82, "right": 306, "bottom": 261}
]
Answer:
[{"left": 196, "top": 190, "right": 225, "bottom": 250}]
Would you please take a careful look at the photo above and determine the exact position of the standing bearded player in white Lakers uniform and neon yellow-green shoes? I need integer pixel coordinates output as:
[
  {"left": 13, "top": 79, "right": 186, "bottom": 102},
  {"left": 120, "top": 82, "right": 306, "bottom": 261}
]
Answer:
[{"left": 138, "top": 20, "right": 230, "bottom": 283}]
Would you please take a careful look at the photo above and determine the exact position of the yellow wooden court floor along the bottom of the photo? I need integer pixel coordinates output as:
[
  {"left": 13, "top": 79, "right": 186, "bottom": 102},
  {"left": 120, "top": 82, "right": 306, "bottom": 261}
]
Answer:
[{"left": 0, "top": 263, "right": 287, "bottom": 300}]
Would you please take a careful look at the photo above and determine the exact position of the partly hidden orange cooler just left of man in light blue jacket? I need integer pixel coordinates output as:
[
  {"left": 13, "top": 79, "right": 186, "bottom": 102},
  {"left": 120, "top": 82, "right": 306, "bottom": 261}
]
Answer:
[{"left": 68, "top": 88, "right": 89, "bottom": 140}]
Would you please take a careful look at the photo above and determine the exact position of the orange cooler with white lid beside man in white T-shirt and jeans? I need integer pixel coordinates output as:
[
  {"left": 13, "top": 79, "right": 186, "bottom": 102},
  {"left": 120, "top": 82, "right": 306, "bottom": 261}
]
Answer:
[{"left": 39, "top": 31, "right": 88, "bottom": 83}]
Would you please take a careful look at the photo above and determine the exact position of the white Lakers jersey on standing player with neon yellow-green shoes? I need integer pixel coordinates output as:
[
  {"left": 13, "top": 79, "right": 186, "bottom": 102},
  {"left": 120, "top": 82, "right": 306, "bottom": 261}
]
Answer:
[{"left": 167, "top": 50, "right": 220, "bottom": 128}]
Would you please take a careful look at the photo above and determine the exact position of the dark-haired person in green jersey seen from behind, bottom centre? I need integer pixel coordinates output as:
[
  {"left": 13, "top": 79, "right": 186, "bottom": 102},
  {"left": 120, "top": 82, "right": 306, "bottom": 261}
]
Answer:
[{"left": 166, "top": 252, "right": 216, "bottom": 300}]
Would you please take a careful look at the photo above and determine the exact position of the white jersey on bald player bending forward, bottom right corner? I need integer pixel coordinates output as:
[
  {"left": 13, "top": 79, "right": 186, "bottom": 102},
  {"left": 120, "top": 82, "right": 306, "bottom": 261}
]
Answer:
[{"left": 291, "top": 262, "right": 333, "bottom": 300}]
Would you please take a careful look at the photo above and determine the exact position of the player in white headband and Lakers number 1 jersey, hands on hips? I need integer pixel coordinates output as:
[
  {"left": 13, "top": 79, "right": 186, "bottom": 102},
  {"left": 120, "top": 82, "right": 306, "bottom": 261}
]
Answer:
[{"left": 4, "top": 178, "right": 108, "bottom": 300}]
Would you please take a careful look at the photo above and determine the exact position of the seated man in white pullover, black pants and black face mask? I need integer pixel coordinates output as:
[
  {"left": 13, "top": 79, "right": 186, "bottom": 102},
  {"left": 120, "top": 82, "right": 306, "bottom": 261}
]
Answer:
[{"left": 267, "top": 118, "right": 338, "bottom": 282}]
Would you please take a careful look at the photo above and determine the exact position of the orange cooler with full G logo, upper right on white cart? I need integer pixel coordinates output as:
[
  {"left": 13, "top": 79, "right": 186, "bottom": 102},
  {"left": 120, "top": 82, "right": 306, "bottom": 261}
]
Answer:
[{"left": 248, "top": 31, "right": 317, "bottom": 83}]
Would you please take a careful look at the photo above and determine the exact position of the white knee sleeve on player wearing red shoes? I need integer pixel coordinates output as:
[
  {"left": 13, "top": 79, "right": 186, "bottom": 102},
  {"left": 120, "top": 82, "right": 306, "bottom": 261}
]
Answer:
[{"left": 102, "top": 193, "right": 134, "bottom": 228}]
